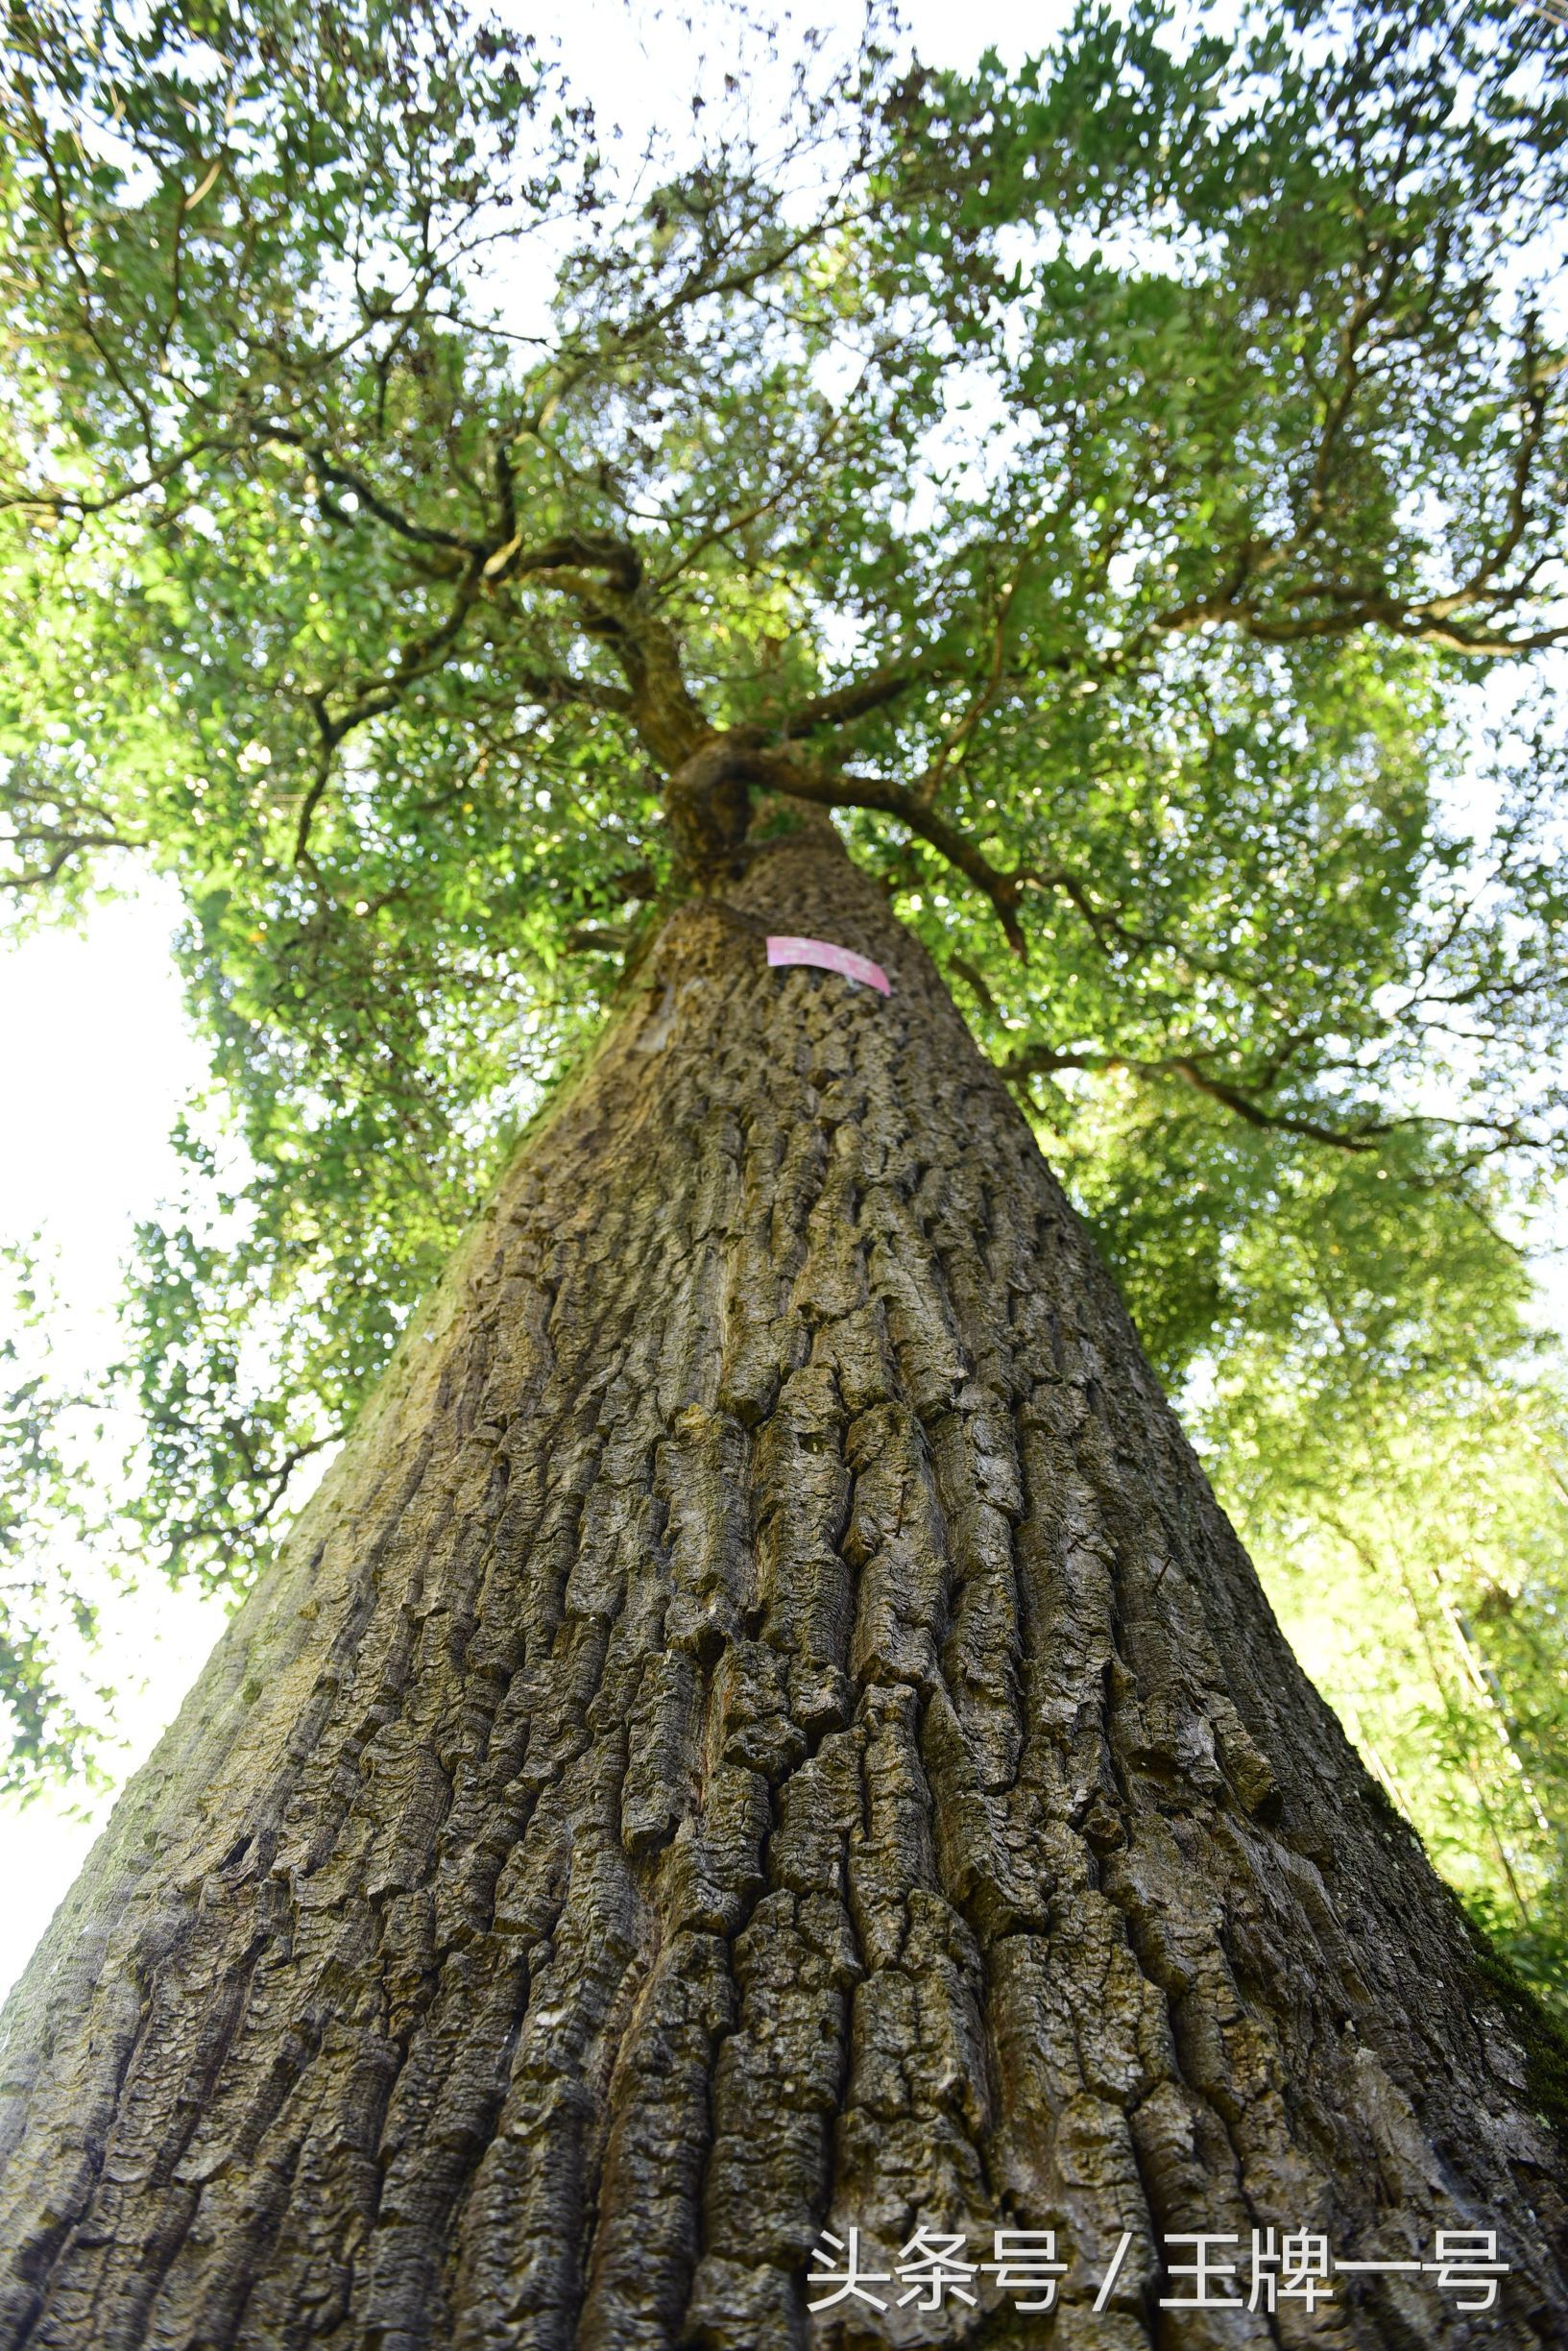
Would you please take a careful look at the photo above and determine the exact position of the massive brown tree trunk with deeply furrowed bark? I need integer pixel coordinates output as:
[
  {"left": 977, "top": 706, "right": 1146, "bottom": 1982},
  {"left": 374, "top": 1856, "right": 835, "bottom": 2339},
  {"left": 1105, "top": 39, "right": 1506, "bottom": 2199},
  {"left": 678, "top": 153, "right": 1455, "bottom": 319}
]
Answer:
[{"left": 0, "top": 833, "right": 1568, "bottom": 2351}]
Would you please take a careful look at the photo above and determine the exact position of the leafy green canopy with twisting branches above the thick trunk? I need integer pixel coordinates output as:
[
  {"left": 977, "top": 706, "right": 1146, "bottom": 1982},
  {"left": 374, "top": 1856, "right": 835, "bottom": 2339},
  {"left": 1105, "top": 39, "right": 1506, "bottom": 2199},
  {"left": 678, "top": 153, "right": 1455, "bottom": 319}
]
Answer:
[{"left": 0, "top": 0, "right": 1568, "bottom": 2002}]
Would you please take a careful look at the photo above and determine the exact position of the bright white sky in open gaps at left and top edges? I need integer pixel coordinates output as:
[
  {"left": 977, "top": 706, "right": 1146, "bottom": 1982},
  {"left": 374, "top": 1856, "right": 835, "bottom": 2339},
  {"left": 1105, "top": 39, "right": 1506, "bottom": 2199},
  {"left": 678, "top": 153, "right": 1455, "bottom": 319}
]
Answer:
[{"left": 0, "top": 0, "right": 1568, "bottom": 1991}]
